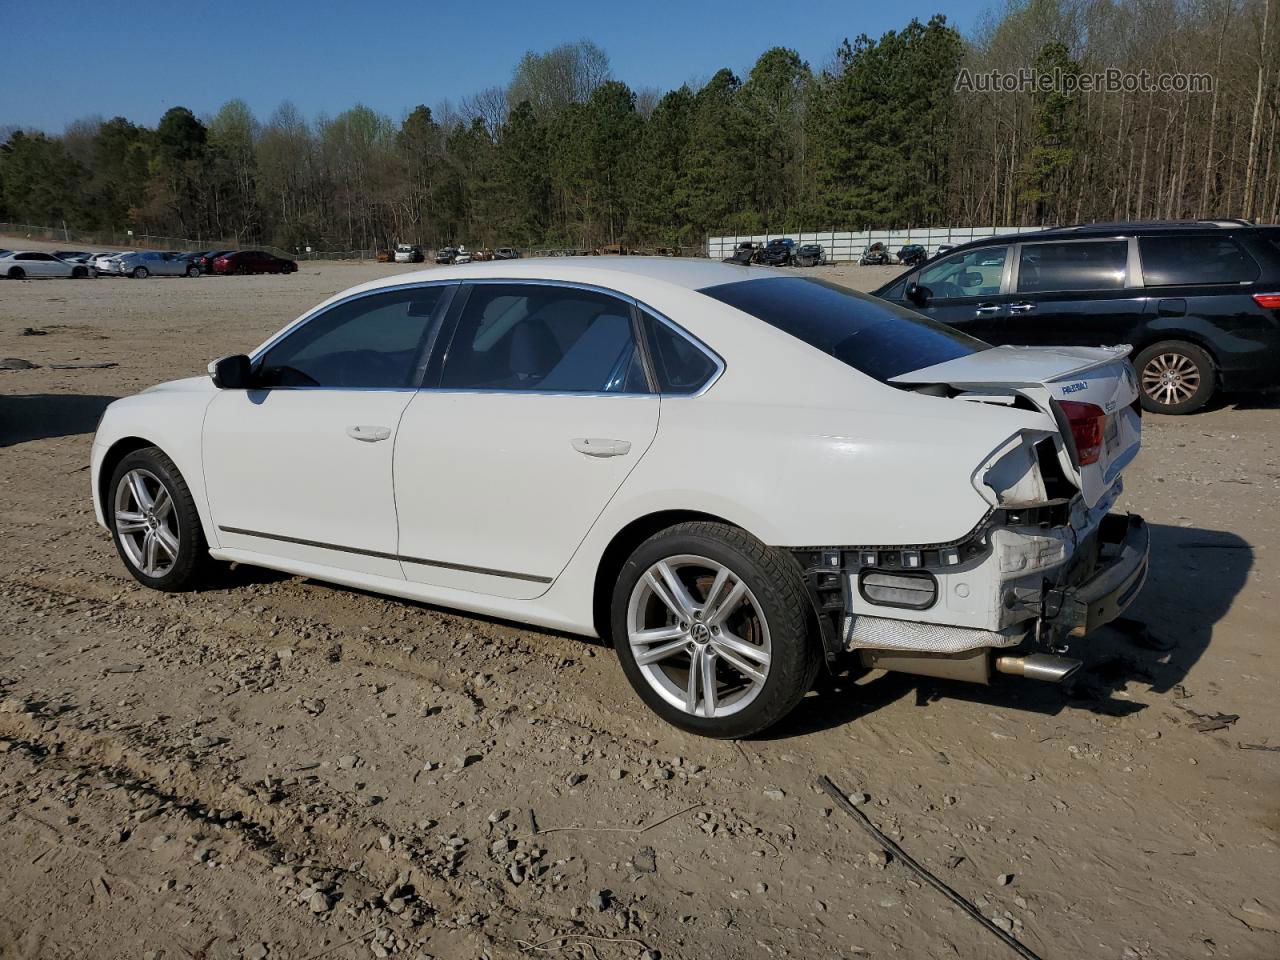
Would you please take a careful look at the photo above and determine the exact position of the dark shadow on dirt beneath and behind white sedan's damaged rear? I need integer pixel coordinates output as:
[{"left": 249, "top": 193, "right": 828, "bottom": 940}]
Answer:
[{"left": 762, "top": 524, "right": 1253, "bottom": 740}]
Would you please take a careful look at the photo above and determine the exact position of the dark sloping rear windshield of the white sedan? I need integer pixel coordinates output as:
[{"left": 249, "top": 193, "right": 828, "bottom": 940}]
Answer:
[{"left": 700, "top": 276, "right": 989, "bottom": 383}]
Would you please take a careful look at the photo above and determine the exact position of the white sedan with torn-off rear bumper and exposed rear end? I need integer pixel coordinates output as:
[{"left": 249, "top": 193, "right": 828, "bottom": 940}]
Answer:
[{"left": 92, "top": 257, "right": 1148, "bottom": 737}]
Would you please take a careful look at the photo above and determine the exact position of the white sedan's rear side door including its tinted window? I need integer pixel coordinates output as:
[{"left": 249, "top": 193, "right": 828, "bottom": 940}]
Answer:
[{"left": 394, "top": 282, "right": 659, "bottom": 599}]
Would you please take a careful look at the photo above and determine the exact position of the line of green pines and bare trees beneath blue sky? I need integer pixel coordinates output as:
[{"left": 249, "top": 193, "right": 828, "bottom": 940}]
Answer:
[{"left": 0, "top": 0, "right": 1280, "bottom": 256}]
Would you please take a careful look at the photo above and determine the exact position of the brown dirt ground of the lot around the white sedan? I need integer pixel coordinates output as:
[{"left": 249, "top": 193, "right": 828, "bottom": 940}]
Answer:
[{"left": 0, "top": 248, "right": 1280, "bottom": 960}]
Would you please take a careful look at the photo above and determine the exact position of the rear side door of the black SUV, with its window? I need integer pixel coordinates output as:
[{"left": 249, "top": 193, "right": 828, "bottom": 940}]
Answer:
[{"left": 1008, "top": 237, "right": 1148, "bottom": 347}]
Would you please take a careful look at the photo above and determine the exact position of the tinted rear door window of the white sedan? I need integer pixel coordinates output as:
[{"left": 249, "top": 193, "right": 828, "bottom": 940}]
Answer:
[{"left": 440, "top": 283, "right": 649, "bottom": 393}]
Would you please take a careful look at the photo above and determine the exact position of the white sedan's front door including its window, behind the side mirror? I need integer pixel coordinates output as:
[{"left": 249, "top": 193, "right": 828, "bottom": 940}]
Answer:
[{"left": 204, "top": 283, "right": 454, "bottom": 580}]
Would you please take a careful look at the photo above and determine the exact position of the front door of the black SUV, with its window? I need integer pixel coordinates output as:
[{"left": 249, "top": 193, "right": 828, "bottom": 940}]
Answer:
[{"left": 904, "top": 243, "right": 1010, "bottom": 339}]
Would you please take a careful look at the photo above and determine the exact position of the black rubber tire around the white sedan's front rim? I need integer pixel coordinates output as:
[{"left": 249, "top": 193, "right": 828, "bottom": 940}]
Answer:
[{"left": 102, "top": 447, "right": 212, "bottom": 593}]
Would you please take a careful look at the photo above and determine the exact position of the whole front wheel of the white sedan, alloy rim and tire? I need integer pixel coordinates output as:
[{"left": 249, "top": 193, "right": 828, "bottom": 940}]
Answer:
[{"left": 104, "top": 447, "right": 210, "bottom": 591}]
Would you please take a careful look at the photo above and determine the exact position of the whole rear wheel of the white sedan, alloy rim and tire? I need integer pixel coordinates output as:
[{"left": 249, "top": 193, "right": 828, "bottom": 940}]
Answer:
[{"left": 612, "top": 522, "right": 818, "bottom": 739}]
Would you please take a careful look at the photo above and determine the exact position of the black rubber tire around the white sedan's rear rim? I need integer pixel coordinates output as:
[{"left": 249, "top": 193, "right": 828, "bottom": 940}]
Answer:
[{"left": 611, "top": 521, "right": 819, "bottom": 739}]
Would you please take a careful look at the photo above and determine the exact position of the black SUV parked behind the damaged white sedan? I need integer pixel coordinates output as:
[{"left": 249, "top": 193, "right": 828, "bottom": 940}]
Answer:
[{"left": 874, "top": 220, "right": 1280, "bottom": 413}]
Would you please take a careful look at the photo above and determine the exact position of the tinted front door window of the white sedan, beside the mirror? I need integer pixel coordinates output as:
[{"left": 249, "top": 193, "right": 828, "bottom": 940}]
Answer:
[{"left": 256, "top": 287, "right": 447, "bottom": 389}]
